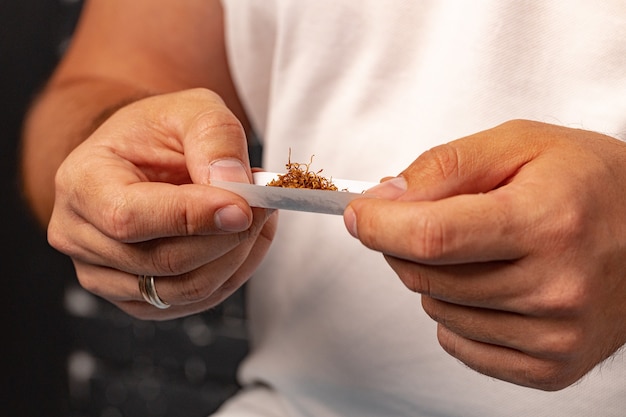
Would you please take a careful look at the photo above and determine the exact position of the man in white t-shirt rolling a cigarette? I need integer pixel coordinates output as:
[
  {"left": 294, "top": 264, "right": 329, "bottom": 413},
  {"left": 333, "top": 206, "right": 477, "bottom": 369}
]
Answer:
[{"left": 25, "top": 0, "right": 626, "bottom": 416}]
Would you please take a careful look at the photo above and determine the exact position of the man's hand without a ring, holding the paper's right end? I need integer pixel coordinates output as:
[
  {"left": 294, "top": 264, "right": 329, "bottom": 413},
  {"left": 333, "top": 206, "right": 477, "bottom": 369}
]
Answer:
[{"left": 345, "top": 121, "right": 626, "bottom": 390}]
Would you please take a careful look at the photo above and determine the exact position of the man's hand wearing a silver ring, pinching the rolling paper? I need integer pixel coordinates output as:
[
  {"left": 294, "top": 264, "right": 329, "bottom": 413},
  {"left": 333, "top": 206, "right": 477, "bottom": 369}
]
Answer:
[{"left": 48, "top": 89, "right": 275, "bottom": 319}]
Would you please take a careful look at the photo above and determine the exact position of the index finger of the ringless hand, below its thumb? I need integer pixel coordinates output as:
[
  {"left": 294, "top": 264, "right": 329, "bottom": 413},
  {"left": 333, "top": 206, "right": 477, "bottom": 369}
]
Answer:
[{"left": 344, "top": 185, "right": 531, "bottom": 265}]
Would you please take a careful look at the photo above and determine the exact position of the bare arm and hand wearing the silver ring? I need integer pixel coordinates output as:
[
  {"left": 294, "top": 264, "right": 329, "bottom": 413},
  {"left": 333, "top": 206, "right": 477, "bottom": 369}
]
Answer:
[{"left": 23, "top": 0, "right": 276, "bottom": 319}]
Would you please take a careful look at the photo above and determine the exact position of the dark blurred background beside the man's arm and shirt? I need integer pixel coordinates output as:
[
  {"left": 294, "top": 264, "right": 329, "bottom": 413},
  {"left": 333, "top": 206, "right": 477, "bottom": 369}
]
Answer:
[{"left": 0, "top": 0, "right": 247, "bottom": 417}]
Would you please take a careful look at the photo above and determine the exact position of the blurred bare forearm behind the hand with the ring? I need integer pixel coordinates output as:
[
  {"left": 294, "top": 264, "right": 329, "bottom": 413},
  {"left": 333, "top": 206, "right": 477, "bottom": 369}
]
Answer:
[{"left": 22, "top": 79, "right": 151, "bottom": 226}]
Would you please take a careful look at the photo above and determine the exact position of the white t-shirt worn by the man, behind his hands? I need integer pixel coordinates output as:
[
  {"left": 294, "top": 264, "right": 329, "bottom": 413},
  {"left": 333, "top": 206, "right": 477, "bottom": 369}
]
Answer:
[{"left": 218, "top": 0, "right": 626, "bottom": 417}]
